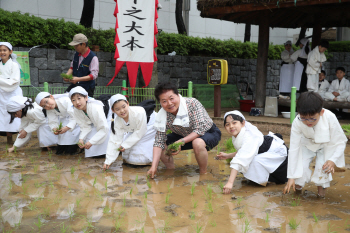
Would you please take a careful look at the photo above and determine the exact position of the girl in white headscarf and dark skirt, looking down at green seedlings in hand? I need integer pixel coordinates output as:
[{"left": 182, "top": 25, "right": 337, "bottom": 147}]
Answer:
[{"left": 35, "top": 92, "right": 80, "bottom": 155}]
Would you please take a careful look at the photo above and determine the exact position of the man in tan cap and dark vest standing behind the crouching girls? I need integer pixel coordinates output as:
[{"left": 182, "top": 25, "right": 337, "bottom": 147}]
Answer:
[{"left": 64, "top": 33, "right": 99, "bottom": 97}]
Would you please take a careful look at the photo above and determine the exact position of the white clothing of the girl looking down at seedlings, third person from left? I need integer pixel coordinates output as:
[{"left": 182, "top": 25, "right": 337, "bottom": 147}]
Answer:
[{"left": 40, "top": 93, "right": 80, "bottom": 145}]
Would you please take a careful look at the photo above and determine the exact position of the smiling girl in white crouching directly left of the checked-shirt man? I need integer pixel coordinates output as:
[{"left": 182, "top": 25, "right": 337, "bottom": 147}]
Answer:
[{"left": 103, "top": 94, "right": 157, "bottom": 169}]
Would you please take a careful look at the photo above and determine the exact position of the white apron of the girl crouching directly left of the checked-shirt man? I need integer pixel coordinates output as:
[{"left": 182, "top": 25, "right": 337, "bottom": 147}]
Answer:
[{"left": 122, "top": 112, "right": 157, "bottom": 165}]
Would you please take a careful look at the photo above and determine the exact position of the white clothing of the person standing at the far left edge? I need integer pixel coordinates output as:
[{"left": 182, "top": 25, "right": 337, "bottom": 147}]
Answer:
[{"left": 0, "top": 59, "right": 23, "bottom": 133}]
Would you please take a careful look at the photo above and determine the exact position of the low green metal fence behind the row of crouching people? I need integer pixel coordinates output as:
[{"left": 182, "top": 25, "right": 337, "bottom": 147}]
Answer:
[{"left": 21, "top": 80, "right": 192, "bottom": 111}]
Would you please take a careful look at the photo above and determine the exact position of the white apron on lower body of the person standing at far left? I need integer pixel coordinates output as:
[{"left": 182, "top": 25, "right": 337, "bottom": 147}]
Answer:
[{"left": 0, "top": 87, "right": 23, "bottom": 133}]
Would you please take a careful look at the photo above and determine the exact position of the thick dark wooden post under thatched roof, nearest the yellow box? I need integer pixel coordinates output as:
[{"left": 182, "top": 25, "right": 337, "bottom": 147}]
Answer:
[{"left": 255, "top": 11, "right": 270, "bottom": 108}]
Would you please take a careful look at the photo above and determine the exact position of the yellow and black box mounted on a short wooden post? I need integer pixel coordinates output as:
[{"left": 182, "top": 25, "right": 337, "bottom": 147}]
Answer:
[{"left": 207, "top": 59, "right": 228, "bottom": 85}]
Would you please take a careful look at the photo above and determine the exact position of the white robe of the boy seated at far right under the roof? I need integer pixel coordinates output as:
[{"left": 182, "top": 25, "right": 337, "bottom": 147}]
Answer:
[{"left": 325, "top": 78, "right": 350, "bottom": 102}]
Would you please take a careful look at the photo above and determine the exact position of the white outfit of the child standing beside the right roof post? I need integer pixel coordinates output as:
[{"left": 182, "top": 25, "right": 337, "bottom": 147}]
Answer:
[{"left": 306, "top": 46, "right": 327, "bottom": 92}]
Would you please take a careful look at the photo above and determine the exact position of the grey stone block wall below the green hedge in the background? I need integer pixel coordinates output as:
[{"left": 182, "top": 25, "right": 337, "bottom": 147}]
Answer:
[{"left": 14, "top": 47, "right": 350, "bottom": 96}]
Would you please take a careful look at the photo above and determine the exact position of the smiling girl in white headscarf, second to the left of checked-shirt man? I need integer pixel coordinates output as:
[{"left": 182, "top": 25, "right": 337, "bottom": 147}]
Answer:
[{"left": 69, "top": 86, "right": 109, "bottom": 157}]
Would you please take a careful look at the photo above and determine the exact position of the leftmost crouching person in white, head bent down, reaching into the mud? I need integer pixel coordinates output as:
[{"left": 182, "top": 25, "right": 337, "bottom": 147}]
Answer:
[{"left": 6, "top": 96, "right": 57, "bottom": 152}]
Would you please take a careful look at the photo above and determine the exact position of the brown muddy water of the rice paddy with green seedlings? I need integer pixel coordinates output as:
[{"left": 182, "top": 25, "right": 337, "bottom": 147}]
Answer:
[{"left": 0, "top": 127, "right": 350, "bottom": 233}]
